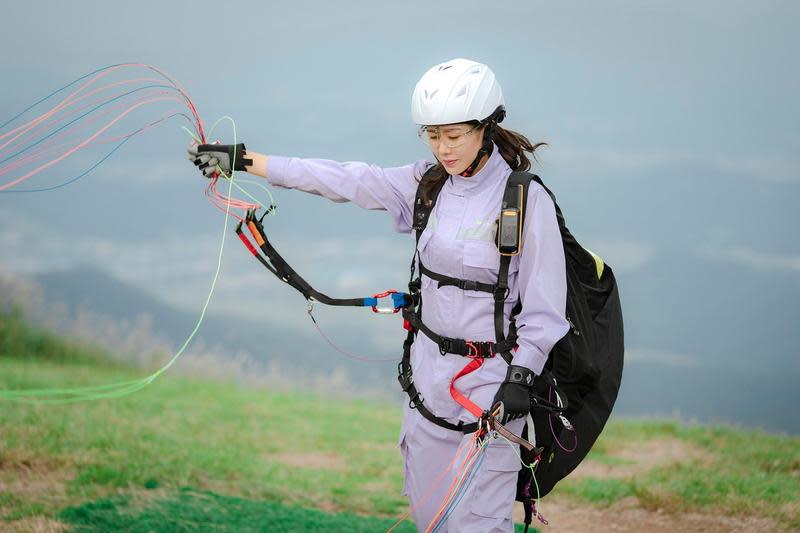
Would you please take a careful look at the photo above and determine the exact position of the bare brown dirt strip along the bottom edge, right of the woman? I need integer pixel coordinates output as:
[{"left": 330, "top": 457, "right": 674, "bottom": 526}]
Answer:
[{"left": 514, "top": 498, "right": 781, "bottom": 533}]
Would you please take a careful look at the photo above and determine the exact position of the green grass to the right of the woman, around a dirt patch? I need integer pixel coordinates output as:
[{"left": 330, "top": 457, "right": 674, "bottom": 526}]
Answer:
[{"left": 557, "top": 420, "right": 800, "bottom": 528}]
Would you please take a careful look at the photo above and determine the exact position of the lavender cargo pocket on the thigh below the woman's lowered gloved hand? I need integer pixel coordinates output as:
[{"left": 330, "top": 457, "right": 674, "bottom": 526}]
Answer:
[{"left": 470, "top": 442, "right": 520, "bottom": 520}]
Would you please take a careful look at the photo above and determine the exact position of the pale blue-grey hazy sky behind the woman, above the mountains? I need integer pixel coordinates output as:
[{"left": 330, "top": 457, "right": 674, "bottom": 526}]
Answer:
[{"left": 0, "top": 1, "right": 800, "bottom": 430}]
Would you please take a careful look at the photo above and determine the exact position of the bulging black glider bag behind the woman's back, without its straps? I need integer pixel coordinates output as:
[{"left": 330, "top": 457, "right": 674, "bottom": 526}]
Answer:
[{"left": 518, "top": 180, "right": 625, "bottom": 497}]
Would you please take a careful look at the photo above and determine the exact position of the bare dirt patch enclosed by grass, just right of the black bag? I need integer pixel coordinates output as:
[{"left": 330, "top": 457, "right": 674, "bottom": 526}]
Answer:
[{"left": 570, "top": 439, "right": 714, "bottom": 479}]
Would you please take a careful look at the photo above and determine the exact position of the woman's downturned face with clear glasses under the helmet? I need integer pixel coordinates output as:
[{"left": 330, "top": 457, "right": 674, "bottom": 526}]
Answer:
[{"left": 420, "top": 123, "right": 483, "bottom": 175}]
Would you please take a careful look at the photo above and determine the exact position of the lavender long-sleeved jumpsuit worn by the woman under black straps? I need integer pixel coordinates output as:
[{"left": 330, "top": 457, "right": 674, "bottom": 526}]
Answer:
[{"left": 267, "top": 143, "right": 569, "bottom": 533}]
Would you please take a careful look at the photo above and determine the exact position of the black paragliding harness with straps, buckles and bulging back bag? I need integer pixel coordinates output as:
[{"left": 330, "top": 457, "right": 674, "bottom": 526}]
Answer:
[{"left": 398, "top": 170, "right": 624, "bottom": 531}]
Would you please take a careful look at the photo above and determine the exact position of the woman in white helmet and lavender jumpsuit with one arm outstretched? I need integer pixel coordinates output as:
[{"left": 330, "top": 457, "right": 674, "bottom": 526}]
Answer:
[{"left": 190, "top": 59, "right": 569, "bottom": 533}]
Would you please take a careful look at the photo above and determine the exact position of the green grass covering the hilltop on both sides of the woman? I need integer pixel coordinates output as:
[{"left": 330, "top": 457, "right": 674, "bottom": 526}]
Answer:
[{"left": 0, "top": 308, "right": 800, "bottom": 531}]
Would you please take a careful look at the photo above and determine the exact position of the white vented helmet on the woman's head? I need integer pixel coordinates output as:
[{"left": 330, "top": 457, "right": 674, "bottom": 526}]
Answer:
[{"left": 411, "top": 59, "right": 505, "bottom": 126}]
